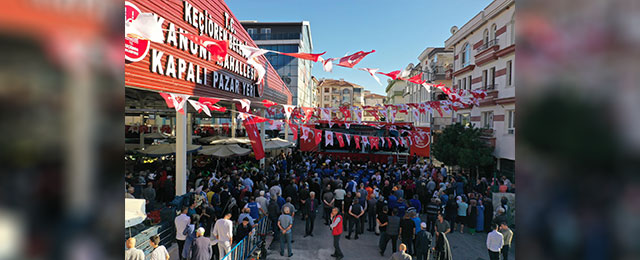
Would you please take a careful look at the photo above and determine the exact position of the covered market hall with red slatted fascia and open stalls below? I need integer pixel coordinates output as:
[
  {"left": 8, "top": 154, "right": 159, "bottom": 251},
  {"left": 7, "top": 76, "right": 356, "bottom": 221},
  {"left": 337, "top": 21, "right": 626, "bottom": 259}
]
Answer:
[{"left": 124, "top": 0, "right": 292, "bottom": 254}]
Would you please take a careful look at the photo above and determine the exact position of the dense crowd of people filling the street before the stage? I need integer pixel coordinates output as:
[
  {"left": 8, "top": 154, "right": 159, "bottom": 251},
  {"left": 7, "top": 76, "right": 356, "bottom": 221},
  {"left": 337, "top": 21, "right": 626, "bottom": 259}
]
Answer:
[{"left": 127, "top": 152, "right": 515, "bottom": 259}]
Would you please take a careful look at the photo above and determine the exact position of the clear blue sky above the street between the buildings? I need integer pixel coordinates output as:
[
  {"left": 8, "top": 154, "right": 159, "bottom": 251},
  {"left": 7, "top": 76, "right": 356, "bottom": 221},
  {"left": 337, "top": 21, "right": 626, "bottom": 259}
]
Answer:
[{"left": 226, "top": 0, "right": 491, "bottom": 95}]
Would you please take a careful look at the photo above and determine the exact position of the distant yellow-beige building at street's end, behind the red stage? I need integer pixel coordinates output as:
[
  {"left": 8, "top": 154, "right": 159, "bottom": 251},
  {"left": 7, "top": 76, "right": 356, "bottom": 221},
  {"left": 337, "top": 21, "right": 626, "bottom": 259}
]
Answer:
[{"left": 317, "top": 79, "right": 364, "bottom": 117}]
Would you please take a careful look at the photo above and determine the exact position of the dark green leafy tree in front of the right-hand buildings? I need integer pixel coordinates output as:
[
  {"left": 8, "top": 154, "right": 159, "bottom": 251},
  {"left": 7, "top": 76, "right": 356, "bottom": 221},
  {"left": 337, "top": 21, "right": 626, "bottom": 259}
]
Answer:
[{"left": 431, "top": 123, "right": 493, "bottom": 176}]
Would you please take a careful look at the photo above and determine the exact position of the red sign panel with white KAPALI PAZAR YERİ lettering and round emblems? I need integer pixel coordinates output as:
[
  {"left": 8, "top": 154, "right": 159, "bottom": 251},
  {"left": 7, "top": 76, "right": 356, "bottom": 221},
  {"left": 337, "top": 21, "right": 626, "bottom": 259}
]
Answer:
[{"left": 125, "top": 1, "right": 266, "bottom": 97}]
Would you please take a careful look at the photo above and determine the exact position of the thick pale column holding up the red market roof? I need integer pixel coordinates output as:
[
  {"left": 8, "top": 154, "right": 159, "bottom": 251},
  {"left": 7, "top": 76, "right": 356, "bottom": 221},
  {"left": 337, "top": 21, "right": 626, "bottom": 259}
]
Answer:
[{"left": 174, "top": 106, "right": 188, "bottom": 196}]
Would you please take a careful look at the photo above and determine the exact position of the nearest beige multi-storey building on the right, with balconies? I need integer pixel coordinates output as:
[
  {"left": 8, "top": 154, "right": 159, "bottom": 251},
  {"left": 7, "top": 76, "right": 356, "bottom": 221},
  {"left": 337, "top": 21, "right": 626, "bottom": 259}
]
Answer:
[{"left": 445, "top": 0, "right": 516, "bottom": 176}]
